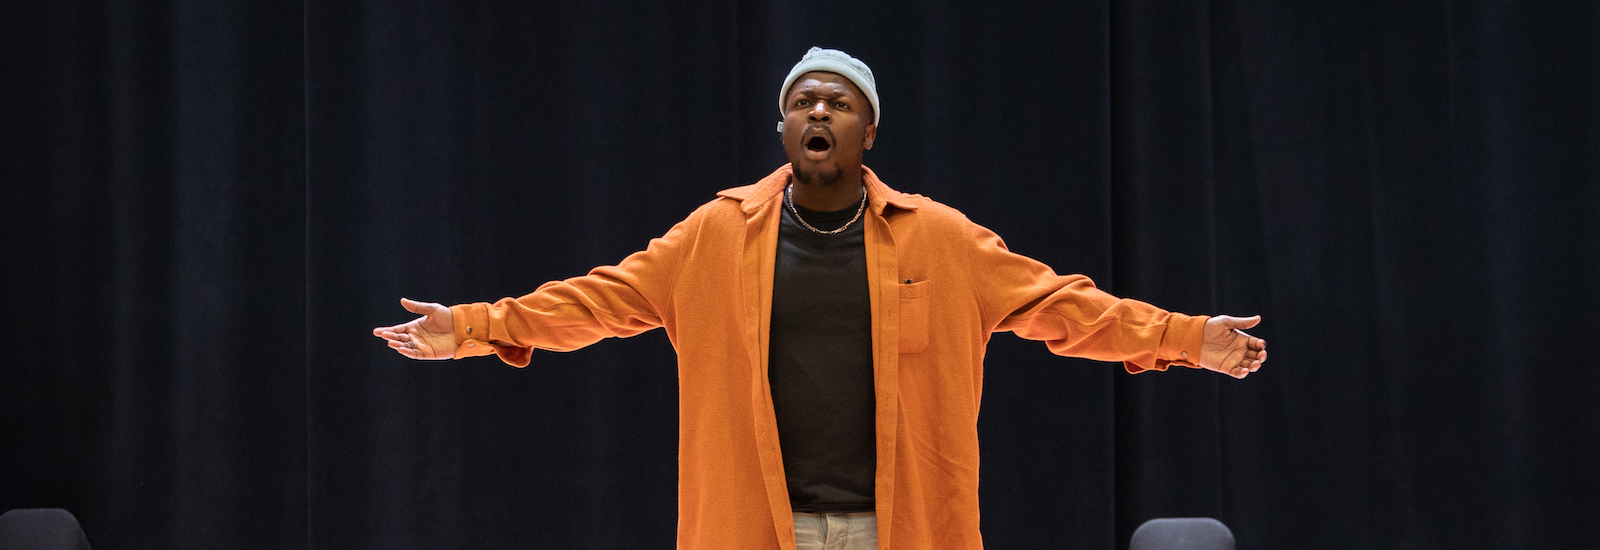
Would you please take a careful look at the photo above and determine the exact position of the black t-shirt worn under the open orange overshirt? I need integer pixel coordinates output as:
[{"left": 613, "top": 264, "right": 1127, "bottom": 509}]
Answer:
[{"left": 768, "top": 196, "right": 877, "bottom": 512}]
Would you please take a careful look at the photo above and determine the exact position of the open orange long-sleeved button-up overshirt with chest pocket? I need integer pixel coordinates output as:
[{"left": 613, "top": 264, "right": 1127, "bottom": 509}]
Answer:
[{"left": 451, "top": 165, "right": 1206, "bottom": 550}]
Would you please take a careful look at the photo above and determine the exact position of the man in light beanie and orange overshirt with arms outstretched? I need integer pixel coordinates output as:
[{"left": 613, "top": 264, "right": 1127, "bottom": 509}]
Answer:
[{"left": 373, "top": 48, "right": 1267, "bottom": 550}]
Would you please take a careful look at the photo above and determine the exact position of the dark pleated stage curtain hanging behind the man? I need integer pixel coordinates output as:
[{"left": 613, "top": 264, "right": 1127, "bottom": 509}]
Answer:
[{"left": 0, "top": 0, "right": 1600, "bottom": 548}]
